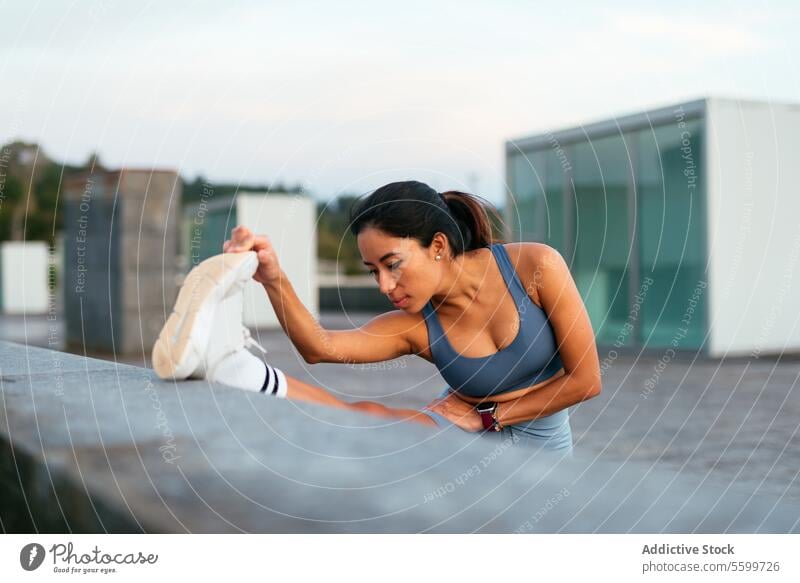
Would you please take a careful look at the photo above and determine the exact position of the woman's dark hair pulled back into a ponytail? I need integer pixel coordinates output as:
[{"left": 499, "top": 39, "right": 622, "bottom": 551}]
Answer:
[{"left": 350, "top": 180, "right": 502, "bottom": 257}]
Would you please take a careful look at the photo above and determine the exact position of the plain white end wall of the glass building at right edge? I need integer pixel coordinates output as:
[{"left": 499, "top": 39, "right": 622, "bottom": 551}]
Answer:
[{"left": 705, "top": 99, "right": 800, "bottom": 356}]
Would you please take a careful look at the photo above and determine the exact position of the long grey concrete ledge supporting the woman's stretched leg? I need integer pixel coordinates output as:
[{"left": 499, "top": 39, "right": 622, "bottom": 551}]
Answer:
[{"left": 0, "top": 342, "right": 800, "bottom": 533}]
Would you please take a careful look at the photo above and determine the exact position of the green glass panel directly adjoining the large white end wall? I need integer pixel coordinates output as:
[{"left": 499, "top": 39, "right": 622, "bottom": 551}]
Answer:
[{"left": 636, "top": 119, "right": 707, "bottom": 349}]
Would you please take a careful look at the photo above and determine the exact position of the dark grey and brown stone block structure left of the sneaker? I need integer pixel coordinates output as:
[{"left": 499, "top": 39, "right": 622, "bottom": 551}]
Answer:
[{"left": 62, "top": 169, "right": 181, "bottom": 358}]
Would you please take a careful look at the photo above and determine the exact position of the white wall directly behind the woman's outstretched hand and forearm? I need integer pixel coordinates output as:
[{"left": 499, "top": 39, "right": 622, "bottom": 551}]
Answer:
[{"left": 236, "top": 193, "right": 319, "bottom": 328}]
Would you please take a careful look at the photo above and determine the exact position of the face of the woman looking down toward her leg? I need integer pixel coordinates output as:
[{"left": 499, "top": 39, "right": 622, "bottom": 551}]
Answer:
[{"left": 357, "top": 227, "right": 443, "bottom": 313}]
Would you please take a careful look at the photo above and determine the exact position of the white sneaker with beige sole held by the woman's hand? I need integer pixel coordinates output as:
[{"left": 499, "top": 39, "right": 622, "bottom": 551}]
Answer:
[{"left": 152, "top": 251, "right": 267, "bottom": 381}]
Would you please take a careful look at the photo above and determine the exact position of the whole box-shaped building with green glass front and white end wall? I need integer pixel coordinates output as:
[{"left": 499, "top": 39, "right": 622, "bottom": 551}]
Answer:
[{"left": 506, "top": 98, "right": 800, "bottom": 357}]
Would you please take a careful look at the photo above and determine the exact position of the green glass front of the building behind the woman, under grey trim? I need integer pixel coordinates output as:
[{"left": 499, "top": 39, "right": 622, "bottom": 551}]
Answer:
[{"left": 506, "top": 102, "right": 707, "bottom": 350}]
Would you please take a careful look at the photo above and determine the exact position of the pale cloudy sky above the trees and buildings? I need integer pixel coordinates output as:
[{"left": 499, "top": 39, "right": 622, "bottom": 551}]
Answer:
[{"left": 0, "top": 0, "right": 800, "bottom": 203}]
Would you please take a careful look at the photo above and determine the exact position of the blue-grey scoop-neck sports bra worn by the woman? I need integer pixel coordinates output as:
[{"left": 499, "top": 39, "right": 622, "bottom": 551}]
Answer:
[{"left": 422, "top": 243, "right": 564, "bottom": 397}]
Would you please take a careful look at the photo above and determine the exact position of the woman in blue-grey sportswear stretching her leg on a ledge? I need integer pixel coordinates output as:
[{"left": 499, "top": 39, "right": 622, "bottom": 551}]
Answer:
[{"left": 153, "top": 181, "right": 600, "bottom": 449}]
